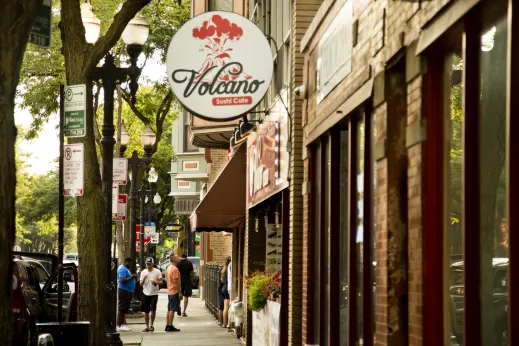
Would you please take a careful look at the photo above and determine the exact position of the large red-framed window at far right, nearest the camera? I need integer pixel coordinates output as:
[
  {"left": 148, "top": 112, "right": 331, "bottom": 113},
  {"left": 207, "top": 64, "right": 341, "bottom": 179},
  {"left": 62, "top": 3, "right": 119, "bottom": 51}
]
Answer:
[{"left": 424, "top": 1, "right": 517, "bottom": 346}]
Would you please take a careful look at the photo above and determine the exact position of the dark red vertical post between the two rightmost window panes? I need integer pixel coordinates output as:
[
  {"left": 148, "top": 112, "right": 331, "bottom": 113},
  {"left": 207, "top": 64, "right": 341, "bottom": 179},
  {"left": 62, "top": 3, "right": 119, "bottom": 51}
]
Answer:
[{"left": 463, "top": 21, "right": 481, "bottom": 346}]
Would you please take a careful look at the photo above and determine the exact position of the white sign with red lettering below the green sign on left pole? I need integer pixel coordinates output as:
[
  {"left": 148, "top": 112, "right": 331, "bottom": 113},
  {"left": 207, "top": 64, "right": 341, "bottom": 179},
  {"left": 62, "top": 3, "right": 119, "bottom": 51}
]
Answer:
[{"left": 63, "top": 143, "right": 85, "bottom": 196}]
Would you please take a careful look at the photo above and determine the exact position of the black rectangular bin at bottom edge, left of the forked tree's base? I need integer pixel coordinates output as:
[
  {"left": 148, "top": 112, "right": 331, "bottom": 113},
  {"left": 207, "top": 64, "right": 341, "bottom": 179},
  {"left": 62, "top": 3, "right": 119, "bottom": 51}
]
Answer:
[{"left": 36, "top": 322, "right": 90, "bottom": 346}]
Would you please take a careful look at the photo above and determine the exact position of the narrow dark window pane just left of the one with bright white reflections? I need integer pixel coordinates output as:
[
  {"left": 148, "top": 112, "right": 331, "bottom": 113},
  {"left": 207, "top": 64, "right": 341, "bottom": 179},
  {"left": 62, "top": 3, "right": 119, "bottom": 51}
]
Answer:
[{"left": 339, "top": 130, "right": 350, "bottom": 346}]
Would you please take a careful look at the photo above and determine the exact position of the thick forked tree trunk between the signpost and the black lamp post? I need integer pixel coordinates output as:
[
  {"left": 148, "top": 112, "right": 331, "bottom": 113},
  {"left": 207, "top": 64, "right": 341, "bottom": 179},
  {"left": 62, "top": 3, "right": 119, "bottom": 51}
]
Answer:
[{"left": 59, "top": 0, "right": 150, "bottom": 346}]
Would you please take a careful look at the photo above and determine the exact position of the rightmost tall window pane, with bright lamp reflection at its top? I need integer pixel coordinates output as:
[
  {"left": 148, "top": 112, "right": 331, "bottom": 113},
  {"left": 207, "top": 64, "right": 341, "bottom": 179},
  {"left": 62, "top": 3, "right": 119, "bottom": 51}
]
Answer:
[{"left": 478, "top": 16, "right": 509, "bottom": 346}]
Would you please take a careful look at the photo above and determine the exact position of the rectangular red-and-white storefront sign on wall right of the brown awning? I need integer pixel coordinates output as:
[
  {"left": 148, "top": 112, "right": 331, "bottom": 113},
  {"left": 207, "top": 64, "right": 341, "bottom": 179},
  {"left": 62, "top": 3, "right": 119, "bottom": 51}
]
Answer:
[{"left": 247, "top": 93, "right": 289, "bottom": 208}]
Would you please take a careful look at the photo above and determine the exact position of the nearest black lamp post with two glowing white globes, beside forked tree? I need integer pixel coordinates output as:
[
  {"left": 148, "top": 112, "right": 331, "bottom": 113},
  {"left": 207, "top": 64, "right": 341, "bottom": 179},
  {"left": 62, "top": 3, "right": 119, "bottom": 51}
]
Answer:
[{"left": 81, "top": 4, "right": 149, "bottom": 346}]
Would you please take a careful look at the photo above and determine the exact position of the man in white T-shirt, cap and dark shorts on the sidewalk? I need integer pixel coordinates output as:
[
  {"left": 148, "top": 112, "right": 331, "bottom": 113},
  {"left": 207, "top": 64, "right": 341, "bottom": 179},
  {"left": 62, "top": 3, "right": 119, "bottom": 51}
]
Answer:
[{"left": 140, "top": 257, "right": 162, "bottom": 332}]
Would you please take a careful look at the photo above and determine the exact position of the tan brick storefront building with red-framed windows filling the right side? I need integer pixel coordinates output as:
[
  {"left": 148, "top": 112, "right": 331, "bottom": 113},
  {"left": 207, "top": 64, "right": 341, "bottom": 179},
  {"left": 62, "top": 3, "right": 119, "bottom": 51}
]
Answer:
[{"left": 294, "top": 0, "right": 517, "bottom": 345}]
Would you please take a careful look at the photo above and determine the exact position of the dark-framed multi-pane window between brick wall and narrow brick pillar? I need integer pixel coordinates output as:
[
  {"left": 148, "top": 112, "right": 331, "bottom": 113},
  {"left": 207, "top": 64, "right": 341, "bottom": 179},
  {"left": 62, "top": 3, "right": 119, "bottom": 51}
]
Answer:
[{"left": 307, "top": 110, "right": 376, "bottom": 346}]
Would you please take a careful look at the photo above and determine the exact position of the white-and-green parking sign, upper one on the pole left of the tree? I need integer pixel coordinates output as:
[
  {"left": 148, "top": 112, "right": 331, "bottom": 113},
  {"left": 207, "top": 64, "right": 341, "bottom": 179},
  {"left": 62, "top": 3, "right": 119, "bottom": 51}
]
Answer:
[{"left": 63, "top": 84, "right": 86, "bottom": 137}]
